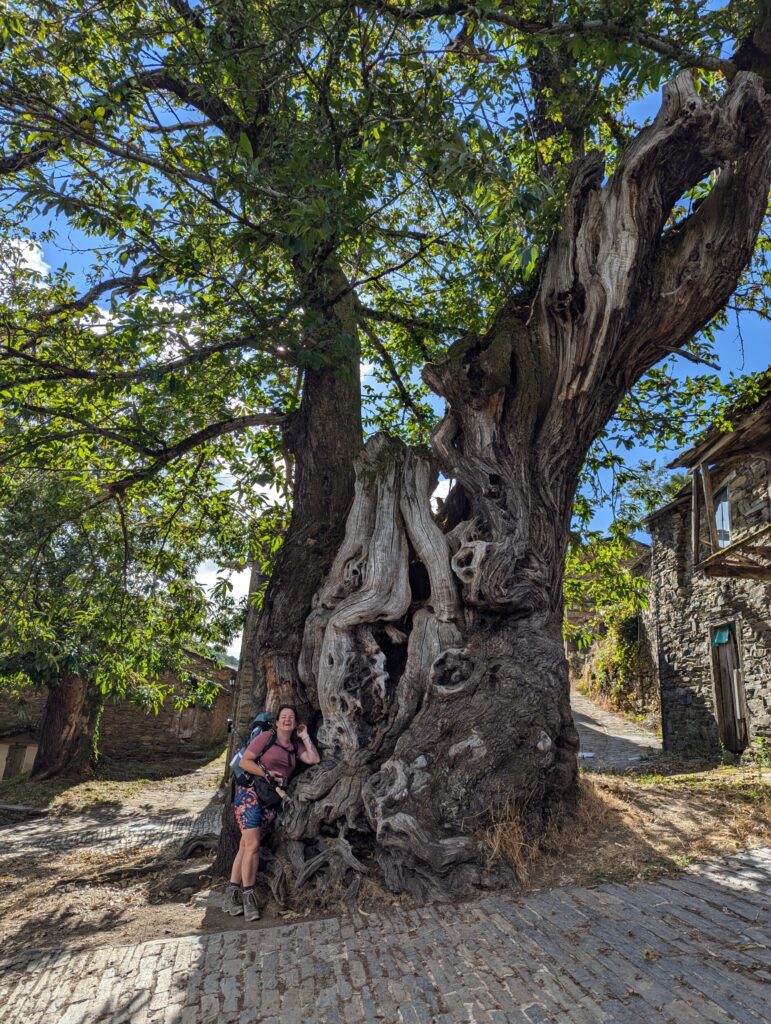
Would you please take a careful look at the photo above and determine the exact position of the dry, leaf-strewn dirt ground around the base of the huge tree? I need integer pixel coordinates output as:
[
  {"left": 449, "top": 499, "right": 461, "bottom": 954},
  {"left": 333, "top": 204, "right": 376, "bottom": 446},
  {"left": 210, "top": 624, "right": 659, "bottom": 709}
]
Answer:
[{"left": 0, "top": 755, "right": 771, "bottom": 962}]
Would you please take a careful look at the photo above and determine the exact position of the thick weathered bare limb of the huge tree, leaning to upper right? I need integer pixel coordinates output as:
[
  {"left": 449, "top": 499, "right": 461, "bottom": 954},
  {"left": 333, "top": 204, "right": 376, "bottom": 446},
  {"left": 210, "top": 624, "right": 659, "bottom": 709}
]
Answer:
[{"left": 532, "top": 72, "right": 771, "bottom": 493}]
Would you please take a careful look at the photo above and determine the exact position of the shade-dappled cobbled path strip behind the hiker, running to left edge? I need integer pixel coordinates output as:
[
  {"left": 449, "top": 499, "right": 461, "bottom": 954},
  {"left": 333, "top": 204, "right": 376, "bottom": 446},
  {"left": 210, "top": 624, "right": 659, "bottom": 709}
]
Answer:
[{"left": 0, "top": 805, "right": 222, "bottom": 871}]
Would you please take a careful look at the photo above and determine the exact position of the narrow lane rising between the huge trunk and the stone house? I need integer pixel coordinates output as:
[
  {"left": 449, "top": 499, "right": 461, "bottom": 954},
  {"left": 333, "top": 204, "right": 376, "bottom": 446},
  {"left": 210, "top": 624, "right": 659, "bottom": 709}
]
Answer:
[{"left": 570, "top": 690, "right": 661, "bottom": 771}]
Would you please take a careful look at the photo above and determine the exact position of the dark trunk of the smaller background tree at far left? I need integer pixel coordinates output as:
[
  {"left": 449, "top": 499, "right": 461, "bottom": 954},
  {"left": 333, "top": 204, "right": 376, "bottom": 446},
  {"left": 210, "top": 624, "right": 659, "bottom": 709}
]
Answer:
[{"left": 32, "top": 672, "right": 101, "bottom": 778}]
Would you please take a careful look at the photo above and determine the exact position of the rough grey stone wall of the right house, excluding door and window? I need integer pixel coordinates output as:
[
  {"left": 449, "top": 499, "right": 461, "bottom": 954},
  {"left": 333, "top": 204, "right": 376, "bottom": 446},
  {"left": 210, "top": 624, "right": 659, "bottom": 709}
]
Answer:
[{"left": 645, "top": 460, "right": 771, "bottom": 754}]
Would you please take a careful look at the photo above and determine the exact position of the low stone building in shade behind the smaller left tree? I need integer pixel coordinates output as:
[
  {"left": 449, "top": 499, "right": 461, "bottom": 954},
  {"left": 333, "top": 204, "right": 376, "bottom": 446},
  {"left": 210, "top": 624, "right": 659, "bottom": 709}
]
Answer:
[{"left": 0, "top": 652, "right": 235, "bottom": 779}]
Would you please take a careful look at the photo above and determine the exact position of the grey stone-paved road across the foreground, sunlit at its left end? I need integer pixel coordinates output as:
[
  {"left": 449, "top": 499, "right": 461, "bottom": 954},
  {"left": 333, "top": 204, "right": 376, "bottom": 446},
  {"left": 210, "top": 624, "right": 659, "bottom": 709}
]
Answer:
[{"left": 0, "top": 849, "right": 771, "bottom": 1024}]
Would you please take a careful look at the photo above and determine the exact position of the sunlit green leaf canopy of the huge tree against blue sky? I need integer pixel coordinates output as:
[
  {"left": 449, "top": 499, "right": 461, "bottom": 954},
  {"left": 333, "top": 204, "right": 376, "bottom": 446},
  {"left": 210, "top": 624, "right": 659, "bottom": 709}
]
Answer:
[{"left": 0, "top": 0, "right": 769, "bottom": 720}]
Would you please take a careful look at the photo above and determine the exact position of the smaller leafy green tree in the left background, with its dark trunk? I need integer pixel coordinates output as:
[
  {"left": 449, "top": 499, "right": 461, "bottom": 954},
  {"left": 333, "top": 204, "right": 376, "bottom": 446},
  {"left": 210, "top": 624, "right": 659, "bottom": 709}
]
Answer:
[{"left": 0, "top": 472, "right": 237, "bottom": 777}]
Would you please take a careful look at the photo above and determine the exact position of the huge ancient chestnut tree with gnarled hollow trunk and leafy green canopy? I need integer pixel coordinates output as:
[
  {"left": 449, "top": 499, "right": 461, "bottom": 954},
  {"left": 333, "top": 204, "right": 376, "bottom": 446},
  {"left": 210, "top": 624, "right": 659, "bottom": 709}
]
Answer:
[{"left": 0, "top": 0, "right": 769, "bottom": 895}]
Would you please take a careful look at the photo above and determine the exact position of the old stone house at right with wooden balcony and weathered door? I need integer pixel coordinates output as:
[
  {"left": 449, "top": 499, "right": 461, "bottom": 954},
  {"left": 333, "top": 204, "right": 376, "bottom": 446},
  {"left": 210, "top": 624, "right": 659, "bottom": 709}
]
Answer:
[{"left": 644, "top": 394, "right": 771, "bottom": 755}]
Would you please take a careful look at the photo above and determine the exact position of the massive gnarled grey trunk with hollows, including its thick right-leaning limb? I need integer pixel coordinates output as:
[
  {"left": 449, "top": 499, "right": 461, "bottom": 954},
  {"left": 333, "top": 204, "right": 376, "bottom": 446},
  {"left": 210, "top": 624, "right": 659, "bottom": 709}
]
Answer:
[{"left": 234, "top": 73, "right": 769, "bottom": 895}]
